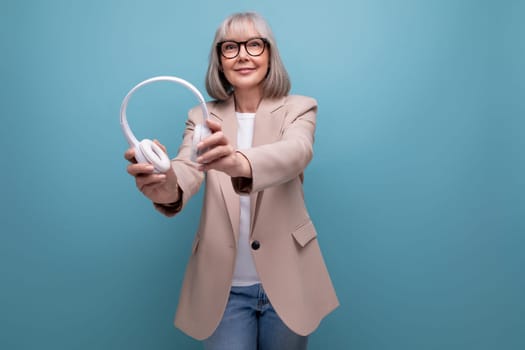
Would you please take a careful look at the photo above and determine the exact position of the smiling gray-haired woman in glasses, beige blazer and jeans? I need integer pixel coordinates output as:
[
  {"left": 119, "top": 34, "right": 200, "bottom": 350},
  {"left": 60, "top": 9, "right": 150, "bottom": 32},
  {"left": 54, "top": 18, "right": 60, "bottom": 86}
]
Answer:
[{"left": 125, "top": 13, "right": 338, "bottom": 350}]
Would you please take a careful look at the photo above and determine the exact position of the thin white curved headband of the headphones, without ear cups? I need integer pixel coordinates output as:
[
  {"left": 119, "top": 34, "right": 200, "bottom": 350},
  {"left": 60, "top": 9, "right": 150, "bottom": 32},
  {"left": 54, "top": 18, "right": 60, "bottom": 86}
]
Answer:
[{"left": 120, "top": 75, "right": 208, "bottom": 146}]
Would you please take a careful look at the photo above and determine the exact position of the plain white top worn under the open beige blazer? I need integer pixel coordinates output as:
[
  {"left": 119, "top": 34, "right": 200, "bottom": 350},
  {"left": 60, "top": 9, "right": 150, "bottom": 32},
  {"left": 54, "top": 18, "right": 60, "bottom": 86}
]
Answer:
[{"left": 232, "top": 112, "right": 260, "bottom": 287}]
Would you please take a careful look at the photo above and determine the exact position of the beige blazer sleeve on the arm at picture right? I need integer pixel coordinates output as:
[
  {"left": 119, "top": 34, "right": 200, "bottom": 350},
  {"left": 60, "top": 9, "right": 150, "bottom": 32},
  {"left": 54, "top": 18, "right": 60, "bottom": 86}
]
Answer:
[{"left": 232, "top": 96, "right": 317, "bottom": 193}]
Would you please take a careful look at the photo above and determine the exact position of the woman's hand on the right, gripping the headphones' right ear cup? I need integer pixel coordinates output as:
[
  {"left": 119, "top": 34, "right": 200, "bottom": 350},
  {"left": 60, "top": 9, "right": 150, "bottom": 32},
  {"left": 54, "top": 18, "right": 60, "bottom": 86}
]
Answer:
[{"left": 197, "top": 120, "right": 252, "bottom": 177}]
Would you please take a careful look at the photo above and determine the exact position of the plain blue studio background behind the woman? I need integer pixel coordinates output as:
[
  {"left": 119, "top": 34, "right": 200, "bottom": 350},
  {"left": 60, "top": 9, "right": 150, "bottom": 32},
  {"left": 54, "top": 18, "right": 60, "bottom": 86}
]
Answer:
[{"left": 0, "top": 0, "right": 525, "bottom": 350}]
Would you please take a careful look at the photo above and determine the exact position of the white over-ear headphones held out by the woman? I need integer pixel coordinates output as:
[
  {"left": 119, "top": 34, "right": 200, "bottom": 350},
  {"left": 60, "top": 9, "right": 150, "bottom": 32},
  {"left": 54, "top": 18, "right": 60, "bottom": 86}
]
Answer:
[{"left": 120, "top": 76, "right": 211, "bottom": 173}]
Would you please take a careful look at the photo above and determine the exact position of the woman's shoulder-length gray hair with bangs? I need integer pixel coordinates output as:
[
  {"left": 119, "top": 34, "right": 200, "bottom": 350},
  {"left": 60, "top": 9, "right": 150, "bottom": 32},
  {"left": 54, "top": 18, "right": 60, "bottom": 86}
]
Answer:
[{"left": 206, "top": 12, "right": 291, "bottom": 101}]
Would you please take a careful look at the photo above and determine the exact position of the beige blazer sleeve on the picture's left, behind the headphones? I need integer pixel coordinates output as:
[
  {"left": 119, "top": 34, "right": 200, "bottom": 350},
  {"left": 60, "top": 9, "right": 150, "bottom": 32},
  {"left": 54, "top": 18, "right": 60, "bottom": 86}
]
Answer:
[{"left": 153, "top": 107, "right": 204, "bottom": 216}]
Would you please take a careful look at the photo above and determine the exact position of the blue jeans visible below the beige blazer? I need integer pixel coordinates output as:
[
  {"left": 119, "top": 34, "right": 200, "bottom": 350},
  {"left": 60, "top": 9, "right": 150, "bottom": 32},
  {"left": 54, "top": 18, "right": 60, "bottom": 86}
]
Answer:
[{"left": 204, "top": 284, "right": 308, "bottom": 350}]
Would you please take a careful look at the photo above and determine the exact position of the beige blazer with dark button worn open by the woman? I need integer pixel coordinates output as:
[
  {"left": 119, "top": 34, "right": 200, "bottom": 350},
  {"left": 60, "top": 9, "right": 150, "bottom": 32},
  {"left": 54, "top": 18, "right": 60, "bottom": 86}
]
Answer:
[{"left": 155, "top": 96, "right": 339, "bottom": 339}]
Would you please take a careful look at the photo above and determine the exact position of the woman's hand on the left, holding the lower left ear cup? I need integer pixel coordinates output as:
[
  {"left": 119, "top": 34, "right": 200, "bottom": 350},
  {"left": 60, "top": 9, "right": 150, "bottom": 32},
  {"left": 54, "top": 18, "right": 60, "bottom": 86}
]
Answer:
[{"left": 124, "top": 140, "right": 179, "bottom": 204}]
